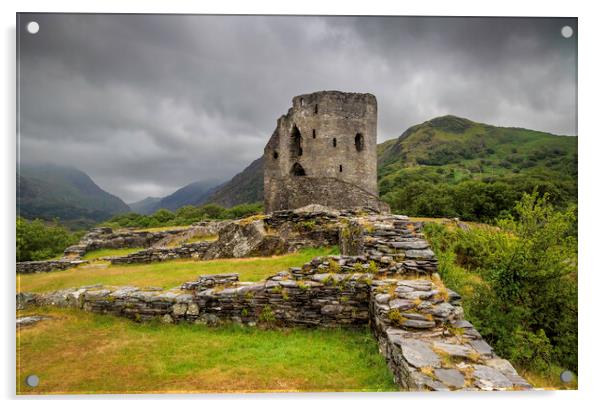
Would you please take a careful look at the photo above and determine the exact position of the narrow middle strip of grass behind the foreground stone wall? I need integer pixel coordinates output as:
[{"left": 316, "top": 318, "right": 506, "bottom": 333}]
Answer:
[{"left": 17, "top": 247, "right": 338, "bottom": 292}]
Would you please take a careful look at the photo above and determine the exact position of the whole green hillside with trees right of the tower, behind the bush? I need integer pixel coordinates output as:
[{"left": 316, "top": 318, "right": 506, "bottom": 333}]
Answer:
[{"left": 378, "top": 116, "right": 577, "bottom": 220}]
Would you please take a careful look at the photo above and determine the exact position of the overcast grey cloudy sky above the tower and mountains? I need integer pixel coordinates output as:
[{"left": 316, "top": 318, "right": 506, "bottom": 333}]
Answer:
[{"left": 18, "top": 14, "right": 577, "bottom": 202}]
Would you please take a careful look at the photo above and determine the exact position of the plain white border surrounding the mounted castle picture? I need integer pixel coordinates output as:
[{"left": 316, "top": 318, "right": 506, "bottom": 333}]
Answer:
[{"left": 0, "top": 0, "right": 602, "bottom": 408}]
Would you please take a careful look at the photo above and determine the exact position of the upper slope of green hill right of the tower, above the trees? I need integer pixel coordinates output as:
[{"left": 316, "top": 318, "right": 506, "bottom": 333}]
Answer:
[{"left": 378, "top": 115, "right": 577, "bottom": 177}]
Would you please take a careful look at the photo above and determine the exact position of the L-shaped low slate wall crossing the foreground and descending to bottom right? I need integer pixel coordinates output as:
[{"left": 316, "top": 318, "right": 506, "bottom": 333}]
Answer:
[{"left": 18, "top": 215, "right": 530, "bottom": 390}]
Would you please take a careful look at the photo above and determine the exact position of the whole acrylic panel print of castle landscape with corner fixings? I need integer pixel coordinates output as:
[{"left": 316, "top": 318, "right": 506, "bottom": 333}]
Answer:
[{"left": 16, "top": 13, "right": 578, "bottom": 394}]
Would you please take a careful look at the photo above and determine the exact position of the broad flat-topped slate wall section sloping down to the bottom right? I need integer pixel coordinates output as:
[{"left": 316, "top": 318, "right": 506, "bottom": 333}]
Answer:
[{"left": 371, "top": 280, "right": 531, "bottom": 391}]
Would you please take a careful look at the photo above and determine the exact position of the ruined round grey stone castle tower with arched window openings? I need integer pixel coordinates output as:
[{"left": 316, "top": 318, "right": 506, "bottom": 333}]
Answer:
[{"left": 263, "top": 91, "right": 388, "bottom": 213}]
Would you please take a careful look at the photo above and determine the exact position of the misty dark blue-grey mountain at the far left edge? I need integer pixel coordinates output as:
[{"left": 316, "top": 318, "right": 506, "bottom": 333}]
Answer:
[{"left": 17, "top": 164, "right": 130, "bottom": 225}]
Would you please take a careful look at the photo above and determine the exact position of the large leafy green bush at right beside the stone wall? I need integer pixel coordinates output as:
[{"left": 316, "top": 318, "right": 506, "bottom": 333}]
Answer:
[{"left": 425, "top": 193, "right": 577, "bottom": 372}]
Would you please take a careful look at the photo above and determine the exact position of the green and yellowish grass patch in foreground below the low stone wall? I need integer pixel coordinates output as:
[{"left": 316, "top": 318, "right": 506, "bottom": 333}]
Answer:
[{"left": 17, "top": 309, "right": 397, "bottom": 394}]
